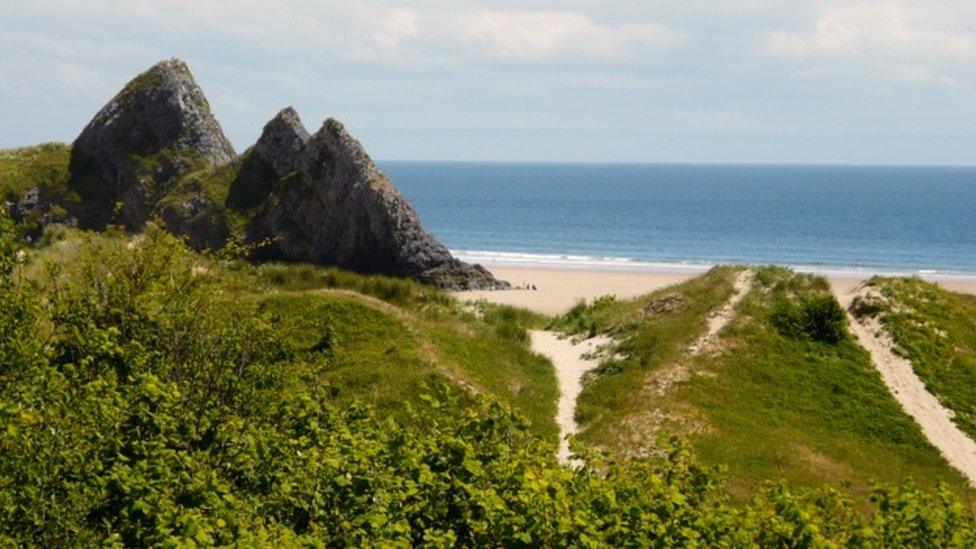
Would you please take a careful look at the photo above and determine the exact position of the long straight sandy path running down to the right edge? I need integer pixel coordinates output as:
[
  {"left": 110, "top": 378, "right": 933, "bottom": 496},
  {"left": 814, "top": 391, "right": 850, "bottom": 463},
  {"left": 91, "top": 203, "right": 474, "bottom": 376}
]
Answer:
[{"left": 838, "top": 287, "right": 976, "bottom": 486}]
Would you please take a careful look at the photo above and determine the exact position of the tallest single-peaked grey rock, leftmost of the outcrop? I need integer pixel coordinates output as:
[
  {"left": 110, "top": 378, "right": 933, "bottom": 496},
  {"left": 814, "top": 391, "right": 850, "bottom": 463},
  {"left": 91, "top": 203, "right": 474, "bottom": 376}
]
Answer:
[{"left": 70, "top": 59, "right": 235, "bottom": 230}]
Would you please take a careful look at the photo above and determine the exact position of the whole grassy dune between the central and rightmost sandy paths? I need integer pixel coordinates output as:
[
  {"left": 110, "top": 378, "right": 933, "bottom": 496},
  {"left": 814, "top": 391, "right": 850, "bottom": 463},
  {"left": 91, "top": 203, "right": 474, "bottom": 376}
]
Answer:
[{"left": 562, "top": 268, "right": 973, "bottom": 500}]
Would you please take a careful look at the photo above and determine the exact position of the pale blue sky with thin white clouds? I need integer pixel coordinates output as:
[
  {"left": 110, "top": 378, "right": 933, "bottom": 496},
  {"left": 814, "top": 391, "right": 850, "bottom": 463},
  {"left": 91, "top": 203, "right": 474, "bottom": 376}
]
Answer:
[{"left": 0, "top": 0, "right": 976, "bottom": 165}]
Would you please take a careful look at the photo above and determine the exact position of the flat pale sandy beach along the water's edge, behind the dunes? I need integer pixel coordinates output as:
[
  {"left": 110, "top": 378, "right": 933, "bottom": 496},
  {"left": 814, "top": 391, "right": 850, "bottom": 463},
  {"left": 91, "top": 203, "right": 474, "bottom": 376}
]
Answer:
[{"left": 455, "top": 266, "right": 976, "bottom": 315}]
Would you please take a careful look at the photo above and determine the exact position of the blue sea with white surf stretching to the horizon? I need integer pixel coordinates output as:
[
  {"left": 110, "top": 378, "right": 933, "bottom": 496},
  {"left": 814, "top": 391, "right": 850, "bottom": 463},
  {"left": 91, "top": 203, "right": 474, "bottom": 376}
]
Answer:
[{"left": 381, "top": 162, "right": 976, "bottom": 274}]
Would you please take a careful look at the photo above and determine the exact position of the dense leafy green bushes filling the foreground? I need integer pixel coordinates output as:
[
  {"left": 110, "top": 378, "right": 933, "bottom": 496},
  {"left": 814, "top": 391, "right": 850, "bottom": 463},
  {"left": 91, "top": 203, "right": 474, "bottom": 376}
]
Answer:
[{"left": 0, "top": 215, "right": 976, "bottom": 547}]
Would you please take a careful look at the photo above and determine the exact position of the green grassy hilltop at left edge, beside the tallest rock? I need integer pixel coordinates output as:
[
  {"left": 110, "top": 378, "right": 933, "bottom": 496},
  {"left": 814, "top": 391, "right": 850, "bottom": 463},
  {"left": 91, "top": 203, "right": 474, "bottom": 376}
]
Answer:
[{"left": 0, "top": 143, "right": 71, "bottom": 200}]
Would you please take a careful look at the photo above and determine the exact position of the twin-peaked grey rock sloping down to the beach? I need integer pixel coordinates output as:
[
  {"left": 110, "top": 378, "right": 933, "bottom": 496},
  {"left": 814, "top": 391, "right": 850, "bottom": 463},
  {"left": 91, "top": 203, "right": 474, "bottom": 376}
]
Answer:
[{"left": 250, "top": 113, "right": 508, "bottom": 289}]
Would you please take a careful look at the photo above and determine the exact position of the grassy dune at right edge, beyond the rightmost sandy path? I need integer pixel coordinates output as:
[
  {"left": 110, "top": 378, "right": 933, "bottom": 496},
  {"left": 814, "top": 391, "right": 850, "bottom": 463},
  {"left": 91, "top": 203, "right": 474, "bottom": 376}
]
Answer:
[{"left": 871, "top": 278, "right": 976, "bottom": 437}]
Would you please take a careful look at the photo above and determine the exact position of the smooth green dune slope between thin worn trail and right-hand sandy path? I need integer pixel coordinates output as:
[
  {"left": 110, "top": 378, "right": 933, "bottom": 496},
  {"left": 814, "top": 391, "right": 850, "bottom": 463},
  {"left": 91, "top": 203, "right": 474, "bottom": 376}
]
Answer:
[{"left": 658, "top": 268, "right": 973, "bottom": 498}]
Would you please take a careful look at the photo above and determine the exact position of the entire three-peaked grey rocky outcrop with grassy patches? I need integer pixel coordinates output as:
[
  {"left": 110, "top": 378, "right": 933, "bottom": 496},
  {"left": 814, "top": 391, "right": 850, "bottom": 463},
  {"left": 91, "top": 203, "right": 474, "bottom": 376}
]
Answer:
[{"left": 8, "top": 59, "right": 508, "bottom": 289}]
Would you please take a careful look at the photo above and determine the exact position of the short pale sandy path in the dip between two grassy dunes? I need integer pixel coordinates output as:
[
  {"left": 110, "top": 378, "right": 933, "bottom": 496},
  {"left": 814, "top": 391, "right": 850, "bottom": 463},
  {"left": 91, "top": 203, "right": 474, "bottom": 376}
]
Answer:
[{"left": 529, "top": 330, "right": 610, "bottom": 463}]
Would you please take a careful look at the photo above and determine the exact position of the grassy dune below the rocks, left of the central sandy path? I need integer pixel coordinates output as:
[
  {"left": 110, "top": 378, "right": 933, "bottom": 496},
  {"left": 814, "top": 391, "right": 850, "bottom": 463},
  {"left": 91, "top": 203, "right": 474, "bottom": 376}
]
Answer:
[{"left": 254, "top": 292, "right": 558, "bottom": 442}]
